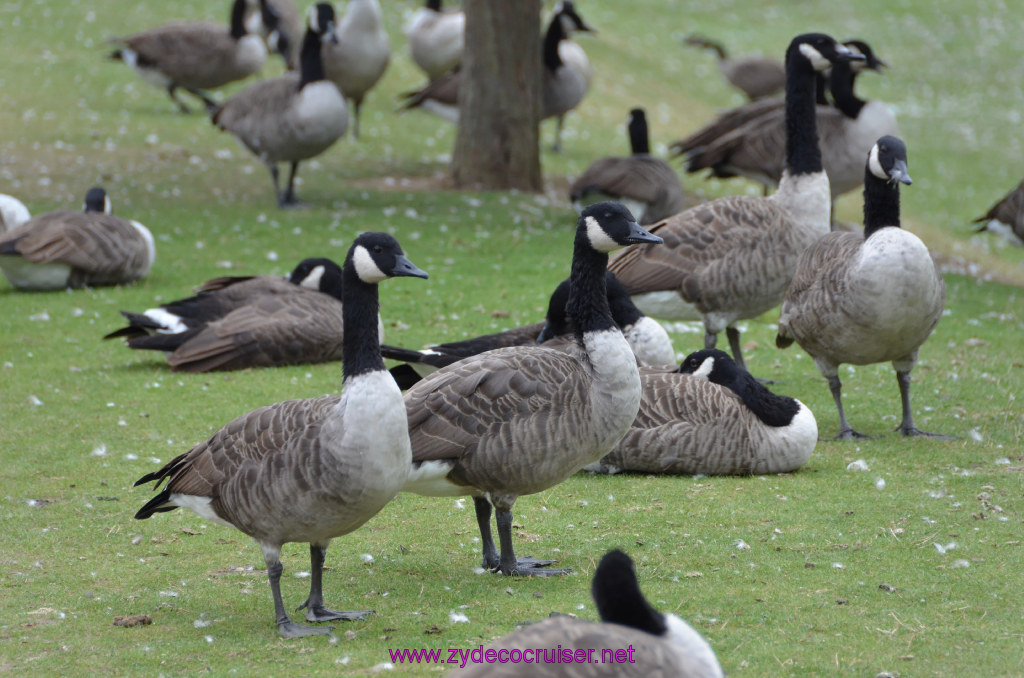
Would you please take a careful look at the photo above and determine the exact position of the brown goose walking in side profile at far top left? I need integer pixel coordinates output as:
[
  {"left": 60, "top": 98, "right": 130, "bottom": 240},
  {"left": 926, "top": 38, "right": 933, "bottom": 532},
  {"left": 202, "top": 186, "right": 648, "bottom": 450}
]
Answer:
[{"left": 110, "top": 0, "right": 266, "bottom": 113}]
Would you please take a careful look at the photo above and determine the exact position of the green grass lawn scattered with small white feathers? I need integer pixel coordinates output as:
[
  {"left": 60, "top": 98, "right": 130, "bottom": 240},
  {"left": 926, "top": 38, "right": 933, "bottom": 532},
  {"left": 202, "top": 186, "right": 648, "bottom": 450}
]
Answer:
[{"left": 0, "top": 0, "right": 1024, "bottom": 676}]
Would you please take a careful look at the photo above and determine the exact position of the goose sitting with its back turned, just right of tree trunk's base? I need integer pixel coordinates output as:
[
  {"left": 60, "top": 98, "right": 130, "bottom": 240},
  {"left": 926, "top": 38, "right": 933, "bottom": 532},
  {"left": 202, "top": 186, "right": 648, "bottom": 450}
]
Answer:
[{"left": 569, "top": 109, "right": 686, "bottom": 225}]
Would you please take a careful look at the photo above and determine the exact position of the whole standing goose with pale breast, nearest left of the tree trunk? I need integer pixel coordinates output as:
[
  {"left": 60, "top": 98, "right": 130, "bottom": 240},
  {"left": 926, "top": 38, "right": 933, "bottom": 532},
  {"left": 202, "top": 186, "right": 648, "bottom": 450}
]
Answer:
[{"left": 212, "top": 2, "right": 348, "bottom": 208}]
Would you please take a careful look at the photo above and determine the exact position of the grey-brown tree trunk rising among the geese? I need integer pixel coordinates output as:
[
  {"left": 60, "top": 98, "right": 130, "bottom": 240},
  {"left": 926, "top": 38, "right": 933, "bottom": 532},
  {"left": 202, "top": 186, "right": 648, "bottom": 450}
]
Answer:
[{"left": 452, "top": 0, "right": 543, "bottom": 190}]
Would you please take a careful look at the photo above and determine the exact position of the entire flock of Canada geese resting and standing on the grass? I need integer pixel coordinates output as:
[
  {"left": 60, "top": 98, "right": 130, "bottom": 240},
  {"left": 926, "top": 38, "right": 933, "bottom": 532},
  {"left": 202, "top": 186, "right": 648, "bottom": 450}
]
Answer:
[{"left": 0, "top": 0, "right": 1024, "bottom": 677}]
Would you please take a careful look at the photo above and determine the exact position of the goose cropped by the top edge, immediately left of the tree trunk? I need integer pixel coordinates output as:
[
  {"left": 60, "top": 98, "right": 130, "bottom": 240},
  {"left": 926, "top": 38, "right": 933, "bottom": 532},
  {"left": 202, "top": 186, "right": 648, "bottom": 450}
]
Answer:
[{"left": 402, "top": 0, "right": 466, "bottom": 82}]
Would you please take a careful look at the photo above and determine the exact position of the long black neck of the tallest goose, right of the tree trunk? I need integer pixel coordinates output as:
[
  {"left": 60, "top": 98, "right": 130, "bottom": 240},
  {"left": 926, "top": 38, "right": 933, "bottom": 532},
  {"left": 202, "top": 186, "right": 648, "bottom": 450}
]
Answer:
[{"left": 785, "top": 49, "right": 822, "bottom": 174}]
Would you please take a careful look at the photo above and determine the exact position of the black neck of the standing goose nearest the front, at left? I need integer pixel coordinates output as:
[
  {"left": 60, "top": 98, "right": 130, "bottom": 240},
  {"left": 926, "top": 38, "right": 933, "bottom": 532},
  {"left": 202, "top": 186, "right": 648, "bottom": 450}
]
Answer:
[{"left": 341, "top": 261, "right": 384, "bottom": 381}]
